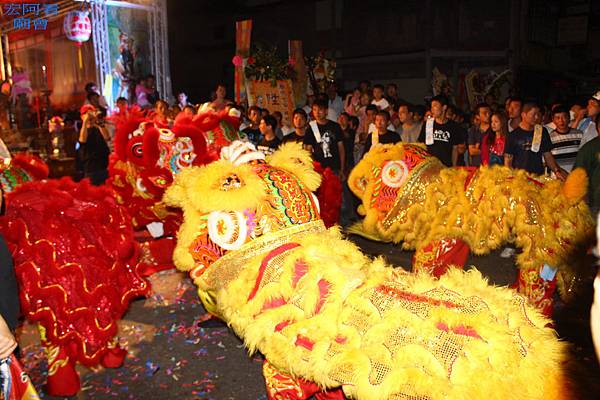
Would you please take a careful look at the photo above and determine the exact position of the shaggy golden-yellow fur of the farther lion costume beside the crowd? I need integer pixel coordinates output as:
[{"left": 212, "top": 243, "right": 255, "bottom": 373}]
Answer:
[{"left": 349, "top": 144, "right": 593, "bottom": 300}]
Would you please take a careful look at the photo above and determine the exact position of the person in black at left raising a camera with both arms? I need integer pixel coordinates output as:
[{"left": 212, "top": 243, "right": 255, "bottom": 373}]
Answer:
[{"left": 79, "top": 104, "right": 110, "bottom": 186}]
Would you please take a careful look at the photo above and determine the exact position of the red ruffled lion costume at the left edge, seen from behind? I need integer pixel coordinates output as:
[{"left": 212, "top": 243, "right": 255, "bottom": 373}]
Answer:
[{"left": 0, "top": 159, "right": 148, "bottom": 396}]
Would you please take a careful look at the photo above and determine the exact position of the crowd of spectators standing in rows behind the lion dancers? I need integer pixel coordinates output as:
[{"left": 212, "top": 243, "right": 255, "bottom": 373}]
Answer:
[{"left": 77, "top": 77, "right": 600, "bottom": 222}]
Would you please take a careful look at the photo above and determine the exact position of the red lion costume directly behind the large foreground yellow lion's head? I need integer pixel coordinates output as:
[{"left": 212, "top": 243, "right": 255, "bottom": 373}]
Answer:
[{"left": 109, "top": 107, "right": 246, "bottom": 275}]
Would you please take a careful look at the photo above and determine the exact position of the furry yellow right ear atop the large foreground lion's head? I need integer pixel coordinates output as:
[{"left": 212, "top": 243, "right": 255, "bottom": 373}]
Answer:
[{"left": 267, "top": 142, "right": 321, "bottom": 192}]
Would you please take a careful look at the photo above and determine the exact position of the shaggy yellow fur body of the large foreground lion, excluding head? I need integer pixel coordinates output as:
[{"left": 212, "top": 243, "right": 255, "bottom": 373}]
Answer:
[{"left": 197, "top": 230, "right": 565, "bottom": 400}]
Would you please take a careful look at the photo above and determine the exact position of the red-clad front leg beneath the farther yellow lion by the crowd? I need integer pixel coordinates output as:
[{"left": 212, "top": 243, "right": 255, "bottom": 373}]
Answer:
[{"left": 413, "top": 239, "right": 469, "bottom": 278}]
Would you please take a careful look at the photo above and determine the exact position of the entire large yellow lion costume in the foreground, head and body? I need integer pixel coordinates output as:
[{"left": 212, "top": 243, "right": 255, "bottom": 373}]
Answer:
[{"left": 164, "top": 142, "right": 569, "bottom": 400}]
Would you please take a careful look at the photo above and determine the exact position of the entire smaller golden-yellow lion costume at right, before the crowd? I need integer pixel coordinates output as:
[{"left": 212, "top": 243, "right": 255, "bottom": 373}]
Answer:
[{"left": 348, "top": 143, "right": 593, "bottom": 316}]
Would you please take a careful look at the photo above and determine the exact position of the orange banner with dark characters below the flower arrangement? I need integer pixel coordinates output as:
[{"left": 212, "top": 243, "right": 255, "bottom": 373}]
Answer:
[{"left": 246, "top": 80, "right": 294, "bottom": 126}]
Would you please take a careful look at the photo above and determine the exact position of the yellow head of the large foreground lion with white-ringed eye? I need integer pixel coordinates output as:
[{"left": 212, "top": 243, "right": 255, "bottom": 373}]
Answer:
[{"left": 164, "top": 142, "right": 321, "bottom": 270}]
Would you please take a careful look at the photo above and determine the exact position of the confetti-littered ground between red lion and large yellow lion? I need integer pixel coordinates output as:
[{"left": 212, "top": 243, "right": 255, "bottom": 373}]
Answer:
[{"left": 19, "top": 271, "right": 266, "bottom": 400}]
